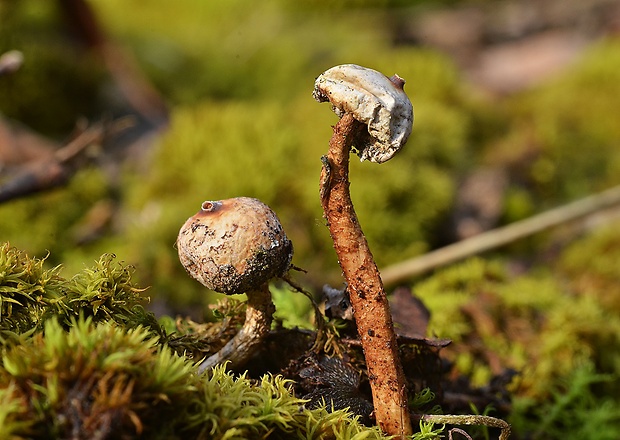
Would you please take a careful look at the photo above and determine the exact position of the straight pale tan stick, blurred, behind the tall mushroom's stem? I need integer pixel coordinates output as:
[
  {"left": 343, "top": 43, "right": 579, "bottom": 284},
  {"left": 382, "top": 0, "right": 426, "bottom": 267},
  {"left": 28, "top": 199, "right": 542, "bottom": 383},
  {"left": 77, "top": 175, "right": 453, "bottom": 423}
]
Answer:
[{"left": 381, "top": 182, "right": 620, "bottom": 285}]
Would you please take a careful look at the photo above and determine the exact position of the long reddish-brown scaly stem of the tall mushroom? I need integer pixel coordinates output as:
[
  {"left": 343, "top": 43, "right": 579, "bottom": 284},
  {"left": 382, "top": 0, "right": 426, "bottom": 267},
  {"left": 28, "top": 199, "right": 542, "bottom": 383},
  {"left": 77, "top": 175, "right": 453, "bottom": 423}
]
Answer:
[{"left": 321, "top": 113, "right": 412, "bottom": 438}]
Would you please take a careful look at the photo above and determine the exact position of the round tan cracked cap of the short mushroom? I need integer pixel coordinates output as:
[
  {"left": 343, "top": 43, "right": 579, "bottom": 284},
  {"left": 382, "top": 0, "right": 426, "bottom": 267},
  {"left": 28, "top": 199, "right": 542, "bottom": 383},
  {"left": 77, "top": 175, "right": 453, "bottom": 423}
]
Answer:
[{"left": 177, "top": 197, "right": 293, "bottom": 295}]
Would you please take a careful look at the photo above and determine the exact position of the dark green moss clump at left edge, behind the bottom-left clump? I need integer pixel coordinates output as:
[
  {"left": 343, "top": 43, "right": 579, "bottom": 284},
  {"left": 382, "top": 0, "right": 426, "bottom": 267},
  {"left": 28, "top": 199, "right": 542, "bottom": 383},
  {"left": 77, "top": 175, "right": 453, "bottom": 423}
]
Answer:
[{"left": 0, "top": 243, "right": 161, "bottom": 344}]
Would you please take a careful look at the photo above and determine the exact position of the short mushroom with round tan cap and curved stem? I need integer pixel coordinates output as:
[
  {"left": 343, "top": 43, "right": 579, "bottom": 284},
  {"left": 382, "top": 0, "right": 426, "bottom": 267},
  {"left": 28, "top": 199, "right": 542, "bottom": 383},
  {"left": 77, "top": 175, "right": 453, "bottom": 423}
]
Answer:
[{"left": 177, "top": 197, "right": 293, "bottom": 373}]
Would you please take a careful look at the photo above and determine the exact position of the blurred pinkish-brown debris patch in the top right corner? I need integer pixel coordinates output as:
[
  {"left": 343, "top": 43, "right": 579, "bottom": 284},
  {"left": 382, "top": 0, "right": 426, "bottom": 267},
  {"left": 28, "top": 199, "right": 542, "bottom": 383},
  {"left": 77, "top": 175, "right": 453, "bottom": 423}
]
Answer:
[{"left": 394, "top": 0, "right": 620, "bottom": 95}]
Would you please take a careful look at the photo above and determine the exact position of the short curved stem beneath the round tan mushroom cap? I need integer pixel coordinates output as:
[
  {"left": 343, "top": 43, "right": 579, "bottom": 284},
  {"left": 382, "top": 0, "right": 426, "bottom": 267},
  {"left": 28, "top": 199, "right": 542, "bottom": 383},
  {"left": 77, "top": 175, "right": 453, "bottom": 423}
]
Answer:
[{"left": 198, "top": 283, "right": 275, "bottom": 374}]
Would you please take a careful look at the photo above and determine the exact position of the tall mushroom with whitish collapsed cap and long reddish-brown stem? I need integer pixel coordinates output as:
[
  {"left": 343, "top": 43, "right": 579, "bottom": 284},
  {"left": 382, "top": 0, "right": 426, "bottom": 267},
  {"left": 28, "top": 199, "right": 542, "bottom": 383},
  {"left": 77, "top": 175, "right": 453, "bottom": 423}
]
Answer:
[{"left": 313, "top": 64, "right": 413, "bottom": 437}]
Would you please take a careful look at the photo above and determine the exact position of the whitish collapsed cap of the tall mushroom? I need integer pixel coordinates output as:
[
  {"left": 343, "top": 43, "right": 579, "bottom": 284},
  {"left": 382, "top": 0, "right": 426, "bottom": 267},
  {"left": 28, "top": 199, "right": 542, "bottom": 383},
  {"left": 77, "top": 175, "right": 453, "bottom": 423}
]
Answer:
[{"left": 313, "top": 64, "right": 413, "bottom": 163}]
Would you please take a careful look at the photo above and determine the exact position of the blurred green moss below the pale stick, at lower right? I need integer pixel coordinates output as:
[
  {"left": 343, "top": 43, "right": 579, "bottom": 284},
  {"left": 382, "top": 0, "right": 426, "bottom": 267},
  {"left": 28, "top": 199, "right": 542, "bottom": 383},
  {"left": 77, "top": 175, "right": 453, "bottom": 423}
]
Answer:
[{"left": 416, "top": 253, "right": 620, "bottom": 439}]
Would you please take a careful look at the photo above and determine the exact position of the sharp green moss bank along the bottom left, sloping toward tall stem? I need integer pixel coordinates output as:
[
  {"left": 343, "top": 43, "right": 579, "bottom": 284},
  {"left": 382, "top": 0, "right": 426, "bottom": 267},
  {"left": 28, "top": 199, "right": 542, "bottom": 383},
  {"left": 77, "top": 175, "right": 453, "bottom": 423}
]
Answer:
[{"left": 0, "top": 312, "right": 390, "bottom": 439}]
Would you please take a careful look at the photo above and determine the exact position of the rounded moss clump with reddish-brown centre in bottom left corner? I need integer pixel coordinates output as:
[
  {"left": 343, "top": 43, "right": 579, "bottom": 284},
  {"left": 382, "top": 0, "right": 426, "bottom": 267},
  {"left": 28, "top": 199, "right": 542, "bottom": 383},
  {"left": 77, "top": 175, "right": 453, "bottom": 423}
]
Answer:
[{"left": 0, "top": 318, "right": 193, "bottom": 438}]
